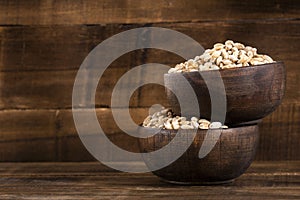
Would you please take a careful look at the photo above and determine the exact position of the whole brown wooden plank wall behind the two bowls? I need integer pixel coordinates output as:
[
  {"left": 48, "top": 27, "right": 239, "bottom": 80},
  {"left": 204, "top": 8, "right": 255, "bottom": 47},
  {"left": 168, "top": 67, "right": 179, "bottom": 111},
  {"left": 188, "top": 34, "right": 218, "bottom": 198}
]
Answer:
[{"left": 0, "top": 0, "right": 300, "bottom": 161}]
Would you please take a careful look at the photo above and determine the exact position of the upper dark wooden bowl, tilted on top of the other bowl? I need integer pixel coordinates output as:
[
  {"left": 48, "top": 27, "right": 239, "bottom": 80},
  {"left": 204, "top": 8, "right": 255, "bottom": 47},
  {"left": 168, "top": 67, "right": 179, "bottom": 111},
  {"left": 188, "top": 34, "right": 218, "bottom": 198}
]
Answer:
[{"left": 164, "top": 62, "right": 286, "bottom": 125}]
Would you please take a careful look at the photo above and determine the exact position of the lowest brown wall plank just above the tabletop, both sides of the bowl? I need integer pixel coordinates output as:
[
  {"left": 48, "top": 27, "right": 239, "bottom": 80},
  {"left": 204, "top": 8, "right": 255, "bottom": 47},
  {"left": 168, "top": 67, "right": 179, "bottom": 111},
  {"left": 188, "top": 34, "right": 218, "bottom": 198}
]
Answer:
[{"left": 0, "top": 104, "right": 300, "bottom": 161}]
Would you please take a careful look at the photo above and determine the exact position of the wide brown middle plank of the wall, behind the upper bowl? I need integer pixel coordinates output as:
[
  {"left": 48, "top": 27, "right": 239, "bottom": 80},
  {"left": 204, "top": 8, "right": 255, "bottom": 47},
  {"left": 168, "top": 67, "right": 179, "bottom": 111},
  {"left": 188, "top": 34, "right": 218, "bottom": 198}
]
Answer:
[{"left": 0, "top": 20, "right": 300, "bottom": 108}]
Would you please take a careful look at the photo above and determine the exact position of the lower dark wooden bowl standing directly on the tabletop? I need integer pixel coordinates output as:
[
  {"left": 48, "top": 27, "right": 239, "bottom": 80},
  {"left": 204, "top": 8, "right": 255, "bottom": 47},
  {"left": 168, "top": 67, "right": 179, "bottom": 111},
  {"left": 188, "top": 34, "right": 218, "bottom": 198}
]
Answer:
[{"left": 139, "top": 125, "right": 259, "bottom": 184}]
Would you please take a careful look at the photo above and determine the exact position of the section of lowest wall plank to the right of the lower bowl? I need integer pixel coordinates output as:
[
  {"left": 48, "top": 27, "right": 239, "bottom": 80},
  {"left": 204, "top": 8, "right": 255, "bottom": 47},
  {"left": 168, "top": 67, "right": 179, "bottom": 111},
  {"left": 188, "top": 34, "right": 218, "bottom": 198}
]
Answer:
[{"left": 256, "top": 104, "right": 300, "bottom": 160}]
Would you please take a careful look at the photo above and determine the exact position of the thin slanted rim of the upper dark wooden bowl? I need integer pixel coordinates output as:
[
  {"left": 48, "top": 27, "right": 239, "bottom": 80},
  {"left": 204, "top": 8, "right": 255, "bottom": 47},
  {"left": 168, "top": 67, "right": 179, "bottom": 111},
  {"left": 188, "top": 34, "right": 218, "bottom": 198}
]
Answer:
[{"left": 164, "top": 61, "right": 284, "bottom": 76}]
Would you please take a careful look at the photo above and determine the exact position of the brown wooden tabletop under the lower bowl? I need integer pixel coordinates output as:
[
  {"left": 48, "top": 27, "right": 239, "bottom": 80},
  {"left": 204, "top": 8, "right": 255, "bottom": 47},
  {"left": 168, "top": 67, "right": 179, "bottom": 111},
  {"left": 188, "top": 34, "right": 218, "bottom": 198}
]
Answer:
[{"left": 0, "top": 161, "right": 300, "bottom": 200}]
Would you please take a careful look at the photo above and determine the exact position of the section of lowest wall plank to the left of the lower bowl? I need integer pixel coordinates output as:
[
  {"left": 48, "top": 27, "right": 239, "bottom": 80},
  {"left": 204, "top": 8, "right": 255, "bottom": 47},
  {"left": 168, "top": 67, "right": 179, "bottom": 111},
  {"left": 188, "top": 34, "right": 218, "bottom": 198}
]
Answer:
[{"left": 0, "top": 108, "right": 148, "bottom": 162}]
